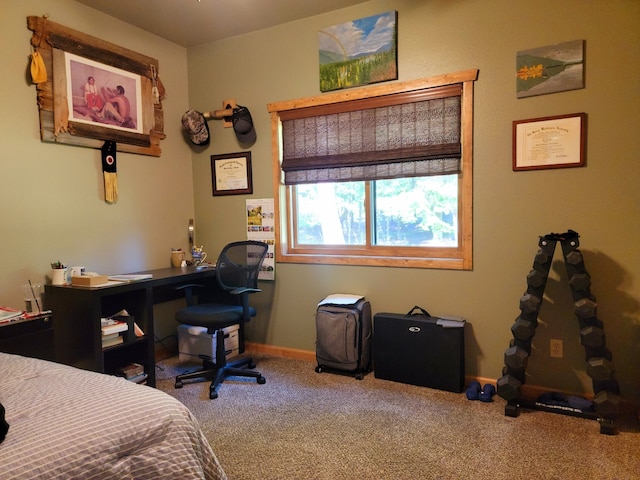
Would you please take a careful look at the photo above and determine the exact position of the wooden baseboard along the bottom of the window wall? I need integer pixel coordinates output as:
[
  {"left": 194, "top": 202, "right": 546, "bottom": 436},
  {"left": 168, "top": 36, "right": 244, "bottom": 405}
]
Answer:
[{"left": 246, "top": 342, "right": 640, "bottom": 417}]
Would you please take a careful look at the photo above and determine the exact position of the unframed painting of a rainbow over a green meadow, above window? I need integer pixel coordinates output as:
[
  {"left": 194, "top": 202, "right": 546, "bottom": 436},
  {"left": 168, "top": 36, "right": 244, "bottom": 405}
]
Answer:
[{"left": 318, "top": 11, "right": 398, "bottom": 92}]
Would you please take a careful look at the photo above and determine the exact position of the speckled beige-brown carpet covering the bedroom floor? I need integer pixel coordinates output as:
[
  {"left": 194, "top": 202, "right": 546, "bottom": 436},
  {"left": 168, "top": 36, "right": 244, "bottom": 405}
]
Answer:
[{"left": 157, "top": 356, "right": 640, "bottom": 480}]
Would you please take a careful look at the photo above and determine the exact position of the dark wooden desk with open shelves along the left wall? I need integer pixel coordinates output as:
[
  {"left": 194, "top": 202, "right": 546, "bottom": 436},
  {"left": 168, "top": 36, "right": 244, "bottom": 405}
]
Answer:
[{"left": 44, "top": 267, "right": 216, "bottom": 386}]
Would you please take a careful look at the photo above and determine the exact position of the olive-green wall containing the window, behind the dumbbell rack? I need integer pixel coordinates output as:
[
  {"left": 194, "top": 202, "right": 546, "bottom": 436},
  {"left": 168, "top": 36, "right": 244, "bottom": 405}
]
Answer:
[{"left": 188, "top": 0, "right": 640, "bottom": 402}]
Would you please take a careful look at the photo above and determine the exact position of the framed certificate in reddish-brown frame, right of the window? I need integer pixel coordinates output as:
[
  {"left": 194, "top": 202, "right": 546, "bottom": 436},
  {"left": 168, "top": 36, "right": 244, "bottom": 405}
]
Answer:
[{"left": 513, "top": 113, "right": 587, "bottom": 170}]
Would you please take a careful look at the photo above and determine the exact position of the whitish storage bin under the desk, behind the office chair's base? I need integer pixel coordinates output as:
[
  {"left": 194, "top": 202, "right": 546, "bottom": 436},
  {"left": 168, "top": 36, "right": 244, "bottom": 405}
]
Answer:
[{"left": 178, "top": 325, "right": 239, "bottom": 362}]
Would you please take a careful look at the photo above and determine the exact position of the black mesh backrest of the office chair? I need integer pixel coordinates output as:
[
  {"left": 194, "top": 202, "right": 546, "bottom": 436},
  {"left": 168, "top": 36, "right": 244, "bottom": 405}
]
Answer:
[{"left": 216, "top": 240, "right": 268, "bottom": 290}]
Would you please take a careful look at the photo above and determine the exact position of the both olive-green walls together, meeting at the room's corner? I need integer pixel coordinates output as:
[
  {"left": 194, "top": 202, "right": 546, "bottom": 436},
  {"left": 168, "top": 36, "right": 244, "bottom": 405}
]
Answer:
[{"left": 0, "top": 0, "right": 640, "bottom": 401}]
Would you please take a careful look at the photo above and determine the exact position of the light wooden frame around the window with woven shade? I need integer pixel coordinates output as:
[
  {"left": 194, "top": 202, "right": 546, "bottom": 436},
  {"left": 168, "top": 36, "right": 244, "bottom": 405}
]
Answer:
[{"left": 268, "top": 69, "right": 478, "bottom": 270}]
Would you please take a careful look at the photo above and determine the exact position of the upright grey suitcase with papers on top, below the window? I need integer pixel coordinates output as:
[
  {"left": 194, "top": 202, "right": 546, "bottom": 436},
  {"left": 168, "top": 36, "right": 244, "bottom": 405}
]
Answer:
[{"left": 316, "top": 295, "right": 372, "bottom": 380}]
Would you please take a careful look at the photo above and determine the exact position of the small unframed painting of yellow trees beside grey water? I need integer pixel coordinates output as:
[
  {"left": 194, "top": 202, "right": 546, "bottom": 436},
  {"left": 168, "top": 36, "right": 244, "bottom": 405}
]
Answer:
[{"left": 516, "top": 40, "right": 584, "bottom": 98}]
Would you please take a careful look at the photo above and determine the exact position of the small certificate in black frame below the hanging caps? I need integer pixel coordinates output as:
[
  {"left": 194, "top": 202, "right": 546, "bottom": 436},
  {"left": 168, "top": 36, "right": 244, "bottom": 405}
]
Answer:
[{"left": 211, "top": 152, "right": 253, "bottom": 197}]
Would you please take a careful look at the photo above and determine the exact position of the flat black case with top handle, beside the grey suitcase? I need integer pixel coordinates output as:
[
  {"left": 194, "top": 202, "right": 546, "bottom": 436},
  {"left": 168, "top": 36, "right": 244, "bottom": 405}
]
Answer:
[{"left": 373, "top": 306, "right": 465, "bottom": 393}]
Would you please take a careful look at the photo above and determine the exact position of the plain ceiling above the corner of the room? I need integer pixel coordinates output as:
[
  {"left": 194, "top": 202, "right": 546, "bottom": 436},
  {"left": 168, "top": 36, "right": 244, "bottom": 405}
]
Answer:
[{"left": 76, "top": 0, "right": 366, "bottom": 47}]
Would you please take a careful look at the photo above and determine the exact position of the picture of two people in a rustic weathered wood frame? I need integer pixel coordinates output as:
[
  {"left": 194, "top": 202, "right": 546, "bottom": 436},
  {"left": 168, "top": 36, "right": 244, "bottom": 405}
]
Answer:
[{"left": 27, "top": 16, "right": 165, "bottom": 156}]
